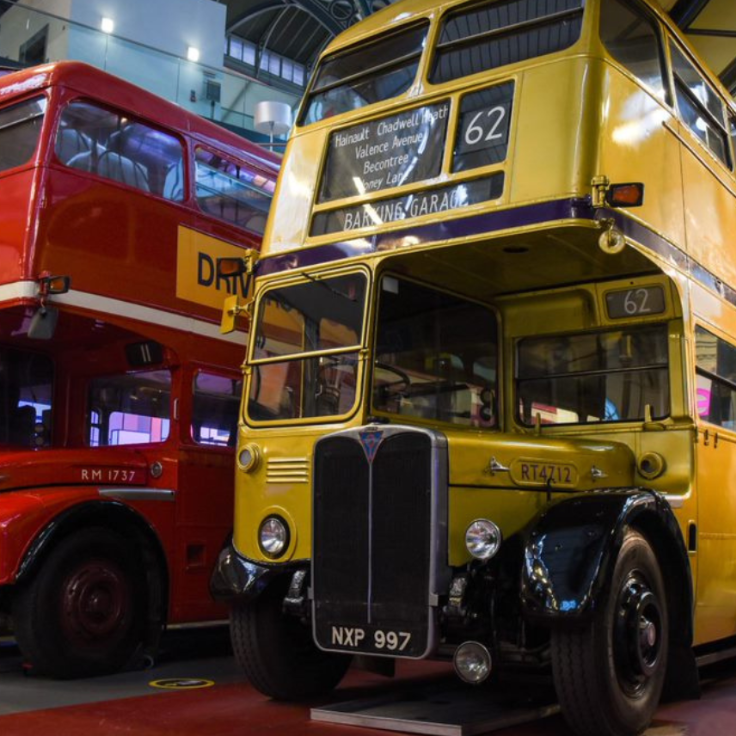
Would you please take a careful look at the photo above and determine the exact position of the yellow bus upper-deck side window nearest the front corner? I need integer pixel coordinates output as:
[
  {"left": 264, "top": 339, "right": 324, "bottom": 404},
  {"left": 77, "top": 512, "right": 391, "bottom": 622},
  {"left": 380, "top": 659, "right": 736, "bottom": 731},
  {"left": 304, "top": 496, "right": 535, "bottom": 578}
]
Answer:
[{"left": 601, "top": 0, "right": 667, "bottom": 100}]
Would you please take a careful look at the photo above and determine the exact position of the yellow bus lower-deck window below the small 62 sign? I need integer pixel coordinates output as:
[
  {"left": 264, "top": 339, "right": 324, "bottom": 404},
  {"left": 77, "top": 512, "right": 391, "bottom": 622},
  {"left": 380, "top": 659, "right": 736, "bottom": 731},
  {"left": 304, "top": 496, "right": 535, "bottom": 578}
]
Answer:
[{"left": 516, "top": 325, "right": 670, "bottom": 425}]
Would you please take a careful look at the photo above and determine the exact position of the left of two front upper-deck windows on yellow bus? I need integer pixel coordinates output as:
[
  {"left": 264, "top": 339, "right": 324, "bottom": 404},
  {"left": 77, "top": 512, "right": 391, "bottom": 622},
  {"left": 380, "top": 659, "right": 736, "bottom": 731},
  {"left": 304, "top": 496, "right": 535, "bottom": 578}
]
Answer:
[{"left": 300, "top": 22, "right": 429, "bottom": 125}]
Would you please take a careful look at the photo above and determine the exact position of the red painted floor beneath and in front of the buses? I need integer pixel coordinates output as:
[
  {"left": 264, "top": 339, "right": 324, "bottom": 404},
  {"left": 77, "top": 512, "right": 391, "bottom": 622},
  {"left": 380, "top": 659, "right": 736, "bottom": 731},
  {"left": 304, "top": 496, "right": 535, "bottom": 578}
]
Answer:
[{"left": 0, "top": 662, "right": 736, "bottom": 736}]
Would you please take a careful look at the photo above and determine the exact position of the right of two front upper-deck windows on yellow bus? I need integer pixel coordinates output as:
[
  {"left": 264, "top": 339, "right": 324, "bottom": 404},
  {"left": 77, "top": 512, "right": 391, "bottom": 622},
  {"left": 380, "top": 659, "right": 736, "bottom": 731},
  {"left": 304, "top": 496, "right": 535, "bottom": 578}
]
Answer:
[{"left": 429, "top": 0, "right": 584, "bottom": 84}]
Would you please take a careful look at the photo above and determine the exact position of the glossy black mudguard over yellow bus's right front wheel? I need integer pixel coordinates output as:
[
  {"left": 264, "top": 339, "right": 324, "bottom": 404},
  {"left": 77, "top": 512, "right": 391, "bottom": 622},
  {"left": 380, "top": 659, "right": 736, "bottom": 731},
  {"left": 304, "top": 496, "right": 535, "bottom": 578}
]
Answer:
[{"left": 521, "top": 488, "right": 693, "bottom": 644}]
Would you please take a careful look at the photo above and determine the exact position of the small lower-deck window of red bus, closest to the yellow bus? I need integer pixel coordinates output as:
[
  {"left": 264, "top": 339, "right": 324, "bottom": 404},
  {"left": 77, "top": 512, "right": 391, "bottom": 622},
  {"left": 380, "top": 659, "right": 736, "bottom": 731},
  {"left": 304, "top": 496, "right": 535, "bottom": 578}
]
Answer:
[{"left": 192, "top": 371, "right": 243, "bottom": 447}]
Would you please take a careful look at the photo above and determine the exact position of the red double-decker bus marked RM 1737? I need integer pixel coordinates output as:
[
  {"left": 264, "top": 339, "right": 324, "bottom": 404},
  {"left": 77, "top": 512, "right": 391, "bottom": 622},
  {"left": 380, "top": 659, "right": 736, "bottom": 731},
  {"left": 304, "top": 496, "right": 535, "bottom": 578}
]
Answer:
[{"left": 0, "top": 62, "right": 278, "bottom": 677}]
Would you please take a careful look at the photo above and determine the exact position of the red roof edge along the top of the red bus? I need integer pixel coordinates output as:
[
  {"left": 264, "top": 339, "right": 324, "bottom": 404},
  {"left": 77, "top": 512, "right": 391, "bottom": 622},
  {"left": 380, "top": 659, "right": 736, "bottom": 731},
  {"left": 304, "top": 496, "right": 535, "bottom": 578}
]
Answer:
[{"left": 0, "top": 61, "right": 280, "bottom": 173}]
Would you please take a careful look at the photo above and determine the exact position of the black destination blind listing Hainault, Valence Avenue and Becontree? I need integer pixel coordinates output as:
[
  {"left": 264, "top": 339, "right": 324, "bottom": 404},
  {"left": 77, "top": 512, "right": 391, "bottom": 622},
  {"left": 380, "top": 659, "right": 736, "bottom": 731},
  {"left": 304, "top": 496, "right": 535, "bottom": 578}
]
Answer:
[{"left": 319, "top": 100, "right": 450, "bottom": 202}]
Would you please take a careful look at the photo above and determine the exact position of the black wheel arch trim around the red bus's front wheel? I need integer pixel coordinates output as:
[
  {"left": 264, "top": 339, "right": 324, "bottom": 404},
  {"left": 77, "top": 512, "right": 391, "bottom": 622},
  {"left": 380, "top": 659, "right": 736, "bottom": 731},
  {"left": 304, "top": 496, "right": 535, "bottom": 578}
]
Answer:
[{"left": 15, "top": 501, "right": 169, "bottom": 654}]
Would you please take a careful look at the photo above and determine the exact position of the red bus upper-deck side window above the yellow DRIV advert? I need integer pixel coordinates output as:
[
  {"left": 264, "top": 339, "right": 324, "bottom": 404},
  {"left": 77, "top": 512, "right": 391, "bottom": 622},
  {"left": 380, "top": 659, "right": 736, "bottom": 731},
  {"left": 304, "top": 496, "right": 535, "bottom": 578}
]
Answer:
[{"left": 195, "top": 148, "right": 276, "bottom": 235}]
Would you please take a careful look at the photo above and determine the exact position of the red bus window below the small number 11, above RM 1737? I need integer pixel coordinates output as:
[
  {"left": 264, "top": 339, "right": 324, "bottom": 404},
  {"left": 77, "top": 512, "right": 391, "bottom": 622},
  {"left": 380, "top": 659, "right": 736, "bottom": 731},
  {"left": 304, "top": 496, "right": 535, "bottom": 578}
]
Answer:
[{"left": 87, "top": 370, "right": 171, "bottom": 447}]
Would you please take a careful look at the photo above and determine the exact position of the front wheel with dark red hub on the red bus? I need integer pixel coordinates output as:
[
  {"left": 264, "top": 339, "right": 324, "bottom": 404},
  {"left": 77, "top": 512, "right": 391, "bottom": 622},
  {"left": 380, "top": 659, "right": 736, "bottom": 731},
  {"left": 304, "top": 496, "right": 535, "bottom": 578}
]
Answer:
[{"left": 12, "top": 528, "right": 146, "bottom": 679}]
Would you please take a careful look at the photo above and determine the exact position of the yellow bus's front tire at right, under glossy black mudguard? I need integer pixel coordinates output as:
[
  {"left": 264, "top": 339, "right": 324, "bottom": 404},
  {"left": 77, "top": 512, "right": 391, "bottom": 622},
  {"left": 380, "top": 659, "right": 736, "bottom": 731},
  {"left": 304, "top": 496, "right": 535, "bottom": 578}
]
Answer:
[{"left": 552, "top": 529, "right": 669, "bottom": 736}]
